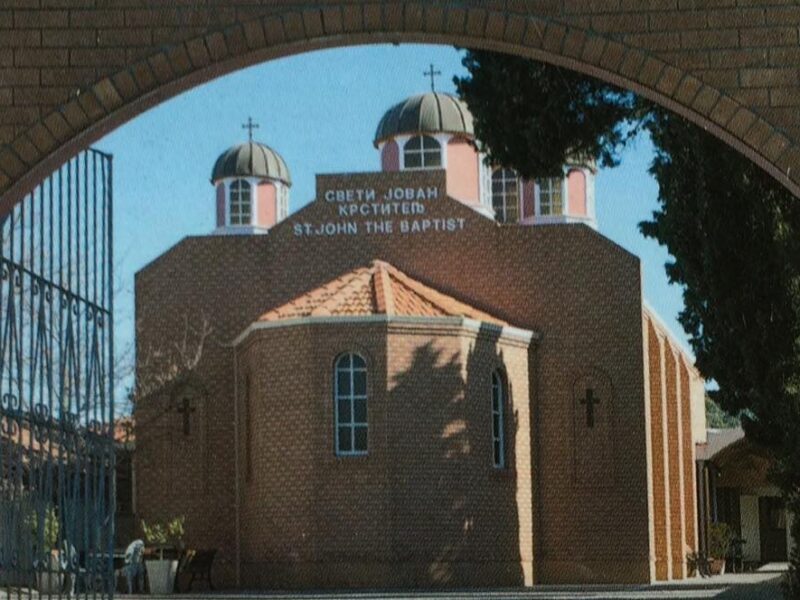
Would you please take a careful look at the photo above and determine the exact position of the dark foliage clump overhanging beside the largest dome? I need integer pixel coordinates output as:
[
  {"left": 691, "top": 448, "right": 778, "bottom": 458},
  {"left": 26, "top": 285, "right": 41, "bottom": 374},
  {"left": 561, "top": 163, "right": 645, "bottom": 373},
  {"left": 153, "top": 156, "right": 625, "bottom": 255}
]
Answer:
[{"left": 455, "top": 50, "right": 639, "bottom": 178}]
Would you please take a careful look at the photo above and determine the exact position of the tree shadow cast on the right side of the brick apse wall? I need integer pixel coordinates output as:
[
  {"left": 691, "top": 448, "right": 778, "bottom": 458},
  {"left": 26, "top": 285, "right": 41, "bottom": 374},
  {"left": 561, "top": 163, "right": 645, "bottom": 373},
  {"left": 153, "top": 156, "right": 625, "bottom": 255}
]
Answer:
[{"left": 389, "top": 334, "right": 529, "bottom": 587}]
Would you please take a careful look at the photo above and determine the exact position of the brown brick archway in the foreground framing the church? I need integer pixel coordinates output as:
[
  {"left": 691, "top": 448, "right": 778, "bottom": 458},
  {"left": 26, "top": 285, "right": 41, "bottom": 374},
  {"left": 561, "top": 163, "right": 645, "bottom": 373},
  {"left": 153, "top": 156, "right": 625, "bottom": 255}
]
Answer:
[{"left": 0, "top": 0, "right": 800, "bottom": 211}]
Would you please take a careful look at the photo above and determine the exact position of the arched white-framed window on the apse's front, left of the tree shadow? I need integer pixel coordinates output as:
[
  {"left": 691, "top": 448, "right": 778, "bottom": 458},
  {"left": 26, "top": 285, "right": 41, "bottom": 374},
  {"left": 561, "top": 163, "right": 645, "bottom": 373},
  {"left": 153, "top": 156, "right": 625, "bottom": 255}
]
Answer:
[{"left": 334, "top": 352, "right": 367, "bottom": 456}]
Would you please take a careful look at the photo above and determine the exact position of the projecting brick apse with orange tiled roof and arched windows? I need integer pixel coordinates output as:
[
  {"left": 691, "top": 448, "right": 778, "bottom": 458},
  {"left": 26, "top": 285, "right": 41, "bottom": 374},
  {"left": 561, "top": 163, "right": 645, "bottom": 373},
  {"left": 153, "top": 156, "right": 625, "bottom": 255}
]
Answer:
[{"left": 228, "top": 261, "right": 533, "bottom": 588}]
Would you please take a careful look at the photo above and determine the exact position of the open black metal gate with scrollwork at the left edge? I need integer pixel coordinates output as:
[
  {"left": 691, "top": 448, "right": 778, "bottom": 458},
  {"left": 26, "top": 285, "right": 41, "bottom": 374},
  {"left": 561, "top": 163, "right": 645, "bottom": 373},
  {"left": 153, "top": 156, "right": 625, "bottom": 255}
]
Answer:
[{"left": 0, "top": 150, "right": 115, "bottom": 598}]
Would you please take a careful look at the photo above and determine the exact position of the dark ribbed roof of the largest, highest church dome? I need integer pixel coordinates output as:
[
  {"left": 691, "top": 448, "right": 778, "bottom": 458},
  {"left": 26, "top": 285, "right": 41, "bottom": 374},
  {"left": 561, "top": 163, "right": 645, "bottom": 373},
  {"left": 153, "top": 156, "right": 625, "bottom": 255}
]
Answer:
[{"left": 375, "top": 92, "right": 475, "bottom": 146}]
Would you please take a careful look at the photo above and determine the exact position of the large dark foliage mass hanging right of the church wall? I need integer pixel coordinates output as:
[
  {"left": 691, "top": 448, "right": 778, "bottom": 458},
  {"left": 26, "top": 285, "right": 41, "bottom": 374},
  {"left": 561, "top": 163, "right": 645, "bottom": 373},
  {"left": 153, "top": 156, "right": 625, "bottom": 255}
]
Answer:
[{"left": 641, "top": 109, "right": 800, "bottom": 447}]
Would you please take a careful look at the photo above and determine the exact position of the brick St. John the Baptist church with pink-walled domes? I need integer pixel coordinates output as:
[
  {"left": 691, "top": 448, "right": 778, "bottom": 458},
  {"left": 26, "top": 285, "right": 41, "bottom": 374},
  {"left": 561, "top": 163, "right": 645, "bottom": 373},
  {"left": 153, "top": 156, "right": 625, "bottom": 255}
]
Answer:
[{"left": 135, "top": 92, "right": 705, "bottom": 589}]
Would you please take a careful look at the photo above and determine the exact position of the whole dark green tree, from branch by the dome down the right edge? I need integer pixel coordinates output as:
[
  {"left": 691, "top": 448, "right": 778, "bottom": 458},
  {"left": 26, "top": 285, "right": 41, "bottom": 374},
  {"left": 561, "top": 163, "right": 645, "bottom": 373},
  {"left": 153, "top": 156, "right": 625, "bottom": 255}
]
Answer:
[{"left": 455, "top": 51, "right": 800, "bottom": 597}]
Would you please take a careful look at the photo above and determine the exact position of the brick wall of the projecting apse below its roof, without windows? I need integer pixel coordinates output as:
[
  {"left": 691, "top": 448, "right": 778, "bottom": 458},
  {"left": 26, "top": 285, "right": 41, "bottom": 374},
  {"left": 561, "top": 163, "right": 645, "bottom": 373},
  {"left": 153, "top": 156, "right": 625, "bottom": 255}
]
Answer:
[{"left": 231, "top": 322, "right": 532, "bottom": 589}]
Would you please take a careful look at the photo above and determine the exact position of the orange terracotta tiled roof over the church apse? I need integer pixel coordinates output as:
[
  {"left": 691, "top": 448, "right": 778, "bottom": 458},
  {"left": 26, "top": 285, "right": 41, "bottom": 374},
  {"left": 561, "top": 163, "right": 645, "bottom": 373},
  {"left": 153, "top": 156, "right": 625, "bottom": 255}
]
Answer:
[{"left": 258, "top": 260, "right": 508, "bottom": 325}]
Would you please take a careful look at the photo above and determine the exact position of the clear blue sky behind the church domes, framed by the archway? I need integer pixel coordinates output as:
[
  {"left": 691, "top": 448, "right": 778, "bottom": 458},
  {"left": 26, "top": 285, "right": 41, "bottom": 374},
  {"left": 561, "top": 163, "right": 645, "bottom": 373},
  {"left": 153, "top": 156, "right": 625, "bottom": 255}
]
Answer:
[{"left": 96, "top": 44, "right": 688, "bottom": 398}]
